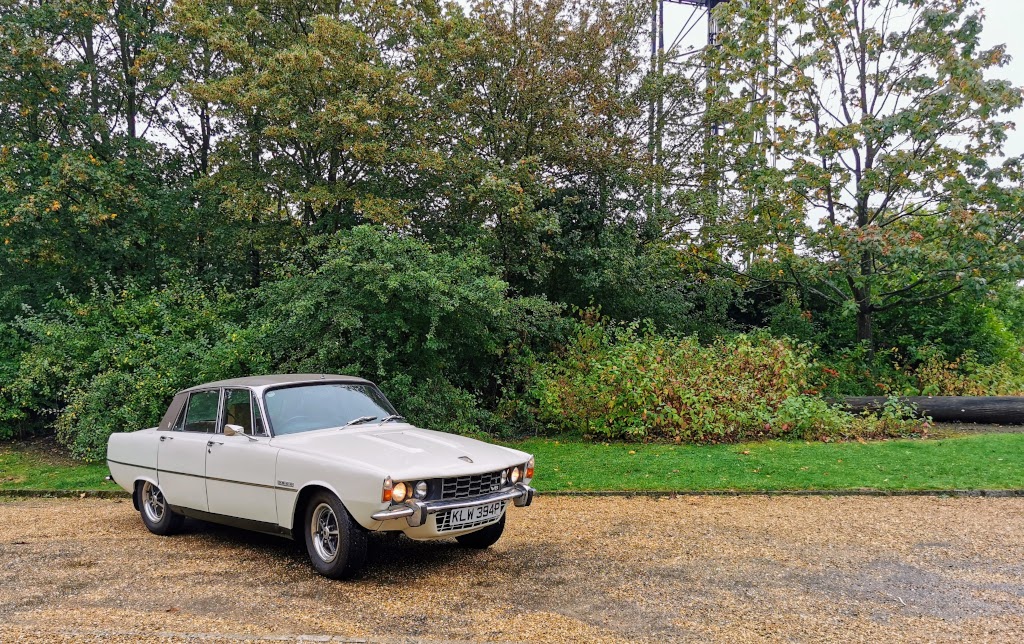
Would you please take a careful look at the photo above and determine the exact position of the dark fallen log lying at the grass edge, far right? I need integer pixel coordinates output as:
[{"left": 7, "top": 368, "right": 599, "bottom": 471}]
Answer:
[{"left": 845, "top": 396, "right": 1024, "bottom": 425}]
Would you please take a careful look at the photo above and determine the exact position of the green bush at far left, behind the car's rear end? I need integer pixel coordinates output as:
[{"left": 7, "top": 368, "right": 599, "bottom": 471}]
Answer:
[{"left": 0, "top": 283, "right": 268, "bottom": 460}]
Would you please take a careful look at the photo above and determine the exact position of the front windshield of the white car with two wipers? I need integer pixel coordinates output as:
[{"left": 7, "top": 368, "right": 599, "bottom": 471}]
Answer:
[{"left": 263, "top": 383, "right": 395, "bottom": 436}]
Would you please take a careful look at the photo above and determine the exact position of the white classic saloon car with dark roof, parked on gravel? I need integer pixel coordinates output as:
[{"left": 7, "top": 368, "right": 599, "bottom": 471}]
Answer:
[{"left": 106, "top": 374, "right": 534, "bottom": 577}]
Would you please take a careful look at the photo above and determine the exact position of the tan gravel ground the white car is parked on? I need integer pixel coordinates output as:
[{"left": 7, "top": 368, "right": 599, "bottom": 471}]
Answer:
[{"left": 0, "top": 497, "right": 1024, "bottom": 642}]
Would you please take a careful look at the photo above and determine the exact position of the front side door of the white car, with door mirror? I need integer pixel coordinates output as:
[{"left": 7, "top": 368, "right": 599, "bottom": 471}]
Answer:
[{"left": 206, "top": 389, "right": 278, "bottom": 523}]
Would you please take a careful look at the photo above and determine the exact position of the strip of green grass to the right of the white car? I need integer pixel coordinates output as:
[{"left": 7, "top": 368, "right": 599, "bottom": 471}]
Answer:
[{"left": 514, "top": 434, "right": 1024, "bottom": 491}]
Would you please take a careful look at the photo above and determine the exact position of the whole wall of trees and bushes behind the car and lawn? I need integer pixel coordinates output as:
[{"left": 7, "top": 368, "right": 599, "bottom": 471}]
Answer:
[{"left": 0, "top": 0, "right": 1024, "bottom": 457}]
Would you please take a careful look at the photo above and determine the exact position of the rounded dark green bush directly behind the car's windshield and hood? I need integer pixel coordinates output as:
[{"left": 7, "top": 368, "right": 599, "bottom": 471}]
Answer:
[{"left": 253, "top": 226, "right": 562, "bottom": 433}]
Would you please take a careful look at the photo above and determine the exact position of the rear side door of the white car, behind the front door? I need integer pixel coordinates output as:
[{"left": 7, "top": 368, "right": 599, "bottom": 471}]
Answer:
[{"left": 157, "top": 389, "right": 220, "bottom": 512}]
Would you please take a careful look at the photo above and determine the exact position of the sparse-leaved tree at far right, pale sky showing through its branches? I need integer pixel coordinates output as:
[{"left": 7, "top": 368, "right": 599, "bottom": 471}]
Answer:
[{"left": 709, "top": 0, "right": 1024, "bottom": 347}]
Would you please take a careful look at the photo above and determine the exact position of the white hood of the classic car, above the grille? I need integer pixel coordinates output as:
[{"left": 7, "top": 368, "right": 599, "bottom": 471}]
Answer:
[{"left": 271, "top": 424, "right": 529, "bottom": 478}]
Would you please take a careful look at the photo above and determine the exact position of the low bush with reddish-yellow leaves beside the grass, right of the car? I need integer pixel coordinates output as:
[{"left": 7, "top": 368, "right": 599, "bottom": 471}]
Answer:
[{"left": 535, "top": 320, "right": 912, "bottom": 442}]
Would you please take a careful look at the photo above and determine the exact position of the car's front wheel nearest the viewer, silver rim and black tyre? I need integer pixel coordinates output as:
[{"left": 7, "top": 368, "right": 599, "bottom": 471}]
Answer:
[{"left": 304, "top": 491, "right": 367, "bottom": 579}]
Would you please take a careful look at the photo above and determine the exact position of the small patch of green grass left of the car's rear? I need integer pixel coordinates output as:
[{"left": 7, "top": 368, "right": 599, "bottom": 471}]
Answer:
[{"left": 0, "top": 445, "right": 120, "bottom": 489}]
